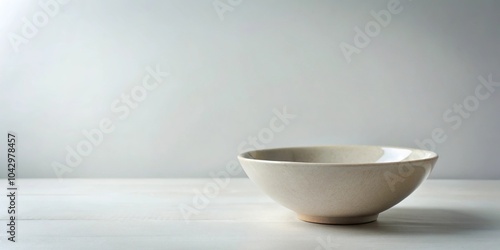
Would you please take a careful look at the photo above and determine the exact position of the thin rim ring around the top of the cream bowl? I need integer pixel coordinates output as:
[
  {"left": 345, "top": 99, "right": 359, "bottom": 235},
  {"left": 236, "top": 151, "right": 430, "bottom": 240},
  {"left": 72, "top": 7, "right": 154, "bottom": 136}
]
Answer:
[{"left": 238, "top": 144, "right": 439, "bottom": 167}]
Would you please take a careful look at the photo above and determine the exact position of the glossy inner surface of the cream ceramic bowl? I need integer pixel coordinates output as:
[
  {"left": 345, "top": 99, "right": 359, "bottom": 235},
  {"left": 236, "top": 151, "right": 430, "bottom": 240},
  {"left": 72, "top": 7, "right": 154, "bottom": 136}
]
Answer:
[{"left": 241, "top": 146, "right": 437, "bottom": 164}]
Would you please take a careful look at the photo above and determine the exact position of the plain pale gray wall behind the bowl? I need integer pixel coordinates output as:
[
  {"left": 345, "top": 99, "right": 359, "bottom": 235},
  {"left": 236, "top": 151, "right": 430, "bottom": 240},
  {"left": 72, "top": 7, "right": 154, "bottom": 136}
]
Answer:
[{"left": 0, "top": 0, "right": 500, "bottom": 179}]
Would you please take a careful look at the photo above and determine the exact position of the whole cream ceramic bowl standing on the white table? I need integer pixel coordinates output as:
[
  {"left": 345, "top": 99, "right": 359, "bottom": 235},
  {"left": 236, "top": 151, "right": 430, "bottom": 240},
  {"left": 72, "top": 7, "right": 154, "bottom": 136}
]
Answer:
[{"left": 238, "top": 145, "right": 438, "bottom": 224}]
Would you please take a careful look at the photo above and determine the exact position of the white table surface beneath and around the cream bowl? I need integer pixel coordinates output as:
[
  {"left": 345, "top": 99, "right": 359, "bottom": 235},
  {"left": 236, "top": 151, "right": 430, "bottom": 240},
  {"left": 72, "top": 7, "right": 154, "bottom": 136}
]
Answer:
[{"left": 0, "top": 178, "right": 500, "bottom": 250}]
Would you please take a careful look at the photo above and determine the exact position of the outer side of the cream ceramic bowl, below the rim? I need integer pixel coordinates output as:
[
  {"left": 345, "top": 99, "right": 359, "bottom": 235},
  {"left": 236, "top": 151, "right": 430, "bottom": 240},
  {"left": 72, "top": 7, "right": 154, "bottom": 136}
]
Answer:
[{"left": 238, "top": 146, "right": 437, "bottom": 220}]
